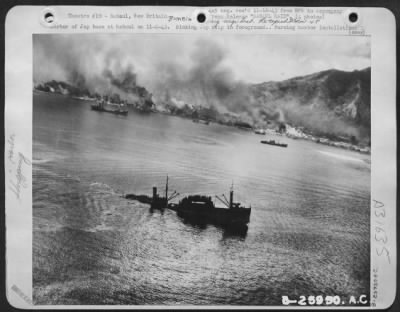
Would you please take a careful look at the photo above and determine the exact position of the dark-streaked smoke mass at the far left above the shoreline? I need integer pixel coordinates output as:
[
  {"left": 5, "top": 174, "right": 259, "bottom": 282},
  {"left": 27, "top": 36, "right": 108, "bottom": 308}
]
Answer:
[{"left": 33, "top": 35, "right": 145, "bottom": 102}]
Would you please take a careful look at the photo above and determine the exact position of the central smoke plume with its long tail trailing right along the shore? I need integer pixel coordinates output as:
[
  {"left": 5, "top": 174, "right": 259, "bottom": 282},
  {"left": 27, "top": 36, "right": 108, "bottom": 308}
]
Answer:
[{"left": 147, "top": 40, "right": 358, "bottom": 135}]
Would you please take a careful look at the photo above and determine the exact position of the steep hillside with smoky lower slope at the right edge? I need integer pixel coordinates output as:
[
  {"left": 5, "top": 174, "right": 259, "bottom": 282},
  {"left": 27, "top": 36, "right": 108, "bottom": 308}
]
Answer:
[{"left": 249, "top": 68, "right": 371, "bottom": 141}]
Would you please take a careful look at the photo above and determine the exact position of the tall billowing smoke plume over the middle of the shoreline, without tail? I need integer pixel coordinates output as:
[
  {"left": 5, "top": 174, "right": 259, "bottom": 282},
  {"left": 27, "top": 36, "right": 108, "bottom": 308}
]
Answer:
[{"left": 148, "top": 39, "right": 260, "bottom": 123}]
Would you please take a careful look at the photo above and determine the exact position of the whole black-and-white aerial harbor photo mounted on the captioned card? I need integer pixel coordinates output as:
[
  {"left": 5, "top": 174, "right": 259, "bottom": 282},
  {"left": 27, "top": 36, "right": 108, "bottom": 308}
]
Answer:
[{"left": 32, "top": 33, "right": 371, "bottom": 307}]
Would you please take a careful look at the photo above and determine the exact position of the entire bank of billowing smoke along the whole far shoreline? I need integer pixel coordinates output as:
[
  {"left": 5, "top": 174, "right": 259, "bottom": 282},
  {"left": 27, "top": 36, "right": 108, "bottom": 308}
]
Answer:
[{"left": 33, "top": 34, "right": 368, "bottom": 140}]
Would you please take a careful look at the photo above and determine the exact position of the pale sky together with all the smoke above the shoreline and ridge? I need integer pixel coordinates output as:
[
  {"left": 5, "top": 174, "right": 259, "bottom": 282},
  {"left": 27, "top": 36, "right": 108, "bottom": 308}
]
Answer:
[{"left": 33, "top": 34, "right": 370, "bottom": 138}]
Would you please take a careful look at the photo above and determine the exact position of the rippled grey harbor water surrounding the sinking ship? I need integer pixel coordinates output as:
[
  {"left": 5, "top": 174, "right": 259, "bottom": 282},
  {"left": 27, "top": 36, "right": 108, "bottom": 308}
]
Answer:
[{"left": 33, "top": 94, "right": 370, "bottom": 305}]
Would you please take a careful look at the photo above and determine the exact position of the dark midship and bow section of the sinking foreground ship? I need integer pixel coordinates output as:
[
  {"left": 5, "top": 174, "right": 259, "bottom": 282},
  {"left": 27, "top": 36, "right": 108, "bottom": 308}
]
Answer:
[{"left": 174, "top": 188, "right": 251, "bottom": 227}]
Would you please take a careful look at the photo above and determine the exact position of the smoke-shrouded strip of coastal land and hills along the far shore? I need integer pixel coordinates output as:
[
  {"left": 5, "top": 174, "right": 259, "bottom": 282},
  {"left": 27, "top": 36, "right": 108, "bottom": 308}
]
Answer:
[{"left": 35, "top": 68, "right": 371, "bottom": 153}]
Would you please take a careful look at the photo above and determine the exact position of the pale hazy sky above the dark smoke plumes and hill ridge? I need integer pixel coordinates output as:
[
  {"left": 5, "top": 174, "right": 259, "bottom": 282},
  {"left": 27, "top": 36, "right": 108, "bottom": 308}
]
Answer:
[{"left": 33, "top": 34, "right": 370, "bottom": 89}]
